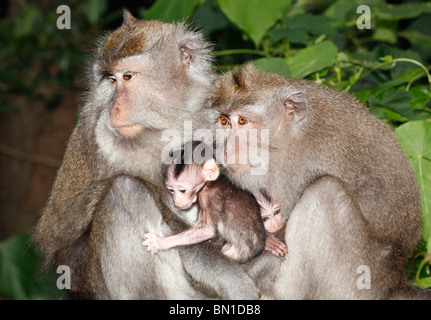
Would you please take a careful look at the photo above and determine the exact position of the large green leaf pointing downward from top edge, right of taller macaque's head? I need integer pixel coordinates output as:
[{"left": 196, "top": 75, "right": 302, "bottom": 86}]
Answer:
[{"left": 218, "top": 0, "right": 290, "bottom": 47}]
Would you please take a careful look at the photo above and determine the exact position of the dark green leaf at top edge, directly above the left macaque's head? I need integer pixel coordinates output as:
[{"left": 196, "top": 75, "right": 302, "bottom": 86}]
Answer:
[{"left": 144, "top": 0, "right": 200, "bottom": 22}]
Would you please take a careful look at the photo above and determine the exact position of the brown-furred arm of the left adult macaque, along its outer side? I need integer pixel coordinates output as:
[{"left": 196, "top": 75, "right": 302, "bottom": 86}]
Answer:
[{"left": 33, "top": 118, "right": 111, "bottom": 266}]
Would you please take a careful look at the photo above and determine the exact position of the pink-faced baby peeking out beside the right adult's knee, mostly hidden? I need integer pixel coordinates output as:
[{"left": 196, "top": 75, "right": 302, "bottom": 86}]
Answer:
[{"left": 253, "top": 191, "right": 287, "bottom": 256}]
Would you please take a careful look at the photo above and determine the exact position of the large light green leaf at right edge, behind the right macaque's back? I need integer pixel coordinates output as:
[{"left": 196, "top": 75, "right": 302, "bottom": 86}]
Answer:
[{"left": 395, "top": 121, "right": 431, "bottom": 252}]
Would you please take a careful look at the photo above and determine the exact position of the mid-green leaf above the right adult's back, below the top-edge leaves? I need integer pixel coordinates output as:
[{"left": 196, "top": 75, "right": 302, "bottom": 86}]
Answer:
[{"left": 287, "top": 41, "right": 338, "bottom": 78}]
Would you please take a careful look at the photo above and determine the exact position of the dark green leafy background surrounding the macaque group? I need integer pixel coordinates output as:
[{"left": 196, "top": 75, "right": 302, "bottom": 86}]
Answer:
[{"left": 0, "top": 0, "right": 431, "bottom": 299}]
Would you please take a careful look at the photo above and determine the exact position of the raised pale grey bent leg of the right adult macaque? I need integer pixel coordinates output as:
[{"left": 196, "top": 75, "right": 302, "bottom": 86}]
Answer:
[{"left": 273, "top": 177, "right": 399, "bottom": 299}]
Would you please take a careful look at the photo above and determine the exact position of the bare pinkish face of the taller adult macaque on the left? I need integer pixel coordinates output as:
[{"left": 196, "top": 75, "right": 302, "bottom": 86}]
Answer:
[{"left": 102, "top": 53, "right": 186, "bottom": 139}]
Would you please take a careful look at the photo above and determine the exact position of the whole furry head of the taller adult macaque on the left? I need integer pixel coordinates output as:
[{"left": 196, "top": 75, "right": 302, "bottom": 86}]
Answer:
[{"left": 91, "top": 16, "right": 213, "bottom": 144}]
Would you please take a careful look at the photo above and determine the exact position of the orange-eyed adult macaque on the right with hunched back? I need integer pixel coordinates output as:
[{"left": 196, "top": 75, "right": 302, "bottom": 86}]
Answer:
[{"left": 213, "top": 64, "right": 429, "bottom": 299}]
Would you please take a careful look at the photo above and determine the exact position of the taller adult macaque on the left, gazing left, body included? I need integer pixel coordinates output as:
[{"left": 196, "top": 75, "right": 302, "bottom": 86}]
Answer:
[{"left": 34, "top": 12, "right": 260, "bottom": 299}]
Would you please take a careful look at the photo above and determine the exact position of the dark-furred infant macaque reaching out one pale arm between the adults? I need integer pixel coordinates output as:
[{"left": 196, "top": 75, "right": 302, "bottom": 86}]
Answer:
[{"left": 142, "top": 145, "right": 287, "bottom": 263}]
